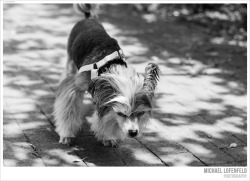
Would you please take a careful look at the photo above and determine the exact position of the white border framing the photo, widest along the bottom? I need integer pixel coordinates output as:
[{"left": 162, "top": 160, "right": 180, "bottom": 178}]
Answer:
[{"left": 0, "top": 0, "right": 249, "bottom": 181}]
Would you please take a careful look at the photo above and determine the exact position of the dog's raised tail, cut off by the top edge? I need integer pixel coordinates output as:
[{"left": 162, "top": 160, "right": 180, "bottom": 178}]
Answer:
[{"left": 74, "top": 4, "right": 99, "bottom": 18}]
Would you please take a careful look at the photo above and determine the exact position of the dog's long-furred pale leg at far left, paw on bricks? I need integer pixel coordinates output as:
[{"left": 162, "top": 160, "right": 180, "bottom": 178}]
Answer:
[{"left": 53, "top": 76, "right": 83, "bottom": 144}]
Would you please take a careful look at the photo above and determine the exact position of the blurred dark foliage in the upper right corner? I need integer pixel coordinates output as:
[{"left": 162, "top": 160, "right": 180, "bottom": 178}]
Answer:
[{"left": 131, "top": 4, "right": 247, "bottom": 41}]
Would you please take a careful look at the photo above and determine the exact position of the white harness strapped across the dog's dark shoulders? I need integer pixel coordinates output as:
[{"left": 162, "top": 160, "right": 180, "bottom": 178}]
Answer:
[{"left": 78, "top": 50, "right": 125, "bottom": 79}]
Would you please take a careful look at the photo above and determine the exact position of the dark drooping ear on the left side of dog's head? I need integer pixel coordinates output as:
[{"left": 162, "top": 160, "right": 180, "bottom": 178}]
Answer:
[{"left": 88, "top": 76, "right": 117, "bottom": 106}]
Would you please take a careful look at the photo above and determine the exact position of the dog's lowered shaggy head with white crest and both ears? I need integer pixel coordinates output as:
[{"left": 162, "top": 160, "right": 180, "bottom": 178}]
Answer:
[{"left": 89, "top": 63, "right": 159, "bottom": 137}]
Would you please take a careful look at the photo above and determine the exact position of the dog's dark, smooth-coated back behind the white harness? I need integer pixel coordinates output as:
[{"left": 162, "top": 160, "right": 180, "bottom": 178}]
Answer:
[{"left": 67, "top": 5, "right": 120, "bottom": 69}]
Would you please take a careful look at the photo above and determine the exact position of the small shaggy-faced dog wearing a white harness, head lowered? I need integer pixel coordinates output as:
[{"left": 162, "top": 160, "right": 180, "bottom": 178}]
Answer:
[{"left": 53, "top": 6, "right": 160, "bottom": 147}]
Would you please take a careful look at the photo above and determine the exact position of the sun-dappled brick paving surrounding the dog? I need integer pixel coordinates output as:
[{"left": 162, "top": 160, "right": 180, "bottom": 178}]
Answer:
[{"left": 3, "top": 4, "right": 247, "bottom": 166}]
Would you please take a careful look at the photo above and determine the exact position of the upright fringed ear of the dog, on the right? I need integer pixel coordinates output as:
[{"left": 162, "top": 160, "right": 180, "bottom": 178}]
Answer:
[{"left": 143, "top": 63, "right": 160, "bottom": 97}]
